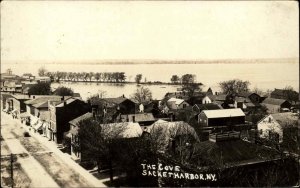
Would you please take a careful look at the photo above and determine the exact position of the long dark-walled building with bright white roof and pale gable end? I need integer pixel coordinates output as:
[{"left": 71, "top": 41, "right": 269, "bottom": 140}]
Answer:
[{"left": 198, "top": 108, "right": 245, "bottom": 127}]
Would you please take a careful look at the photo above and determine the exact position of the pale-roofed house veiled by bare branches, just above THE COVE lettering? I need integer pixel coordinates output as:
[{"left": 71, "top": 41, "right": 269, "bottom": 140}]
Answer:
[{"left": 144, "top": 120, "right": 199, "bottom": 152}]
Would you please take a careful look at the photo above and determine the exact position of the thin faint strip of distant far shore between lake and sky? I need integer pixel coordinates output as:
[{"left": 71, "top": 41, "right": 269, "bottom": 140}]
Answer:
[{"left": 2, "top": 57, "right": 299, "bottom": 65}]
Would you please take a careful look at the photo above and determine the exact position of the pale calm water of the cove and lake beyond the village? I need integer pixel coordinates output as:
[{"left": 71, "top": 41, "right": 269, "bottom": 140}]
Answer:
[{"left": 1, "top": 61, "right": 299, "bottom": 99}]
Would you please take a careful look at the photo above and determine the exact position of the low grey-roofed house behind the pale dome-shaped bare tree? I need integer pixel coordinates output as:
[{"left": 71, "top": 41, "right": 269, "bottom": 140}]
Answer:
[{"left": 119, "top": 113, "right": 155, "bottom": 127}]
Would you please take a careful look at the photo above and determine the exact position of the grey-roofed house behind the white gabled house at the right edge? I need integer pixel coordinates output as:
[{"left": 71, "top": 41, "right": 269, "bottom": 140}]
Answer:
[{"left": 262, "top": 98, "right": 292, "bottom": 113}]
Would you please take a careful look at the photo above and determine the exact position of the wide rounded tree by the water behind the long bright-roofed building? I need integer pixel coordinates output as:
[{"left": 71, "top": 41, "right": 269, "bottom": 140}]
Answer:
[{"left": 219, "top": 79, "right": 250, "bottom": 94}]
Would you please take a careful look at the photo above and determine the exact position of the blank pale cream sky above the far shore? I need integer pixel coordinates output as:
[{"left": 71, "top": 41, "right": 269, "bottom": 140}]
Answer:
[{"left": 1, "top": 1, "right": 299, "bottom": 62}]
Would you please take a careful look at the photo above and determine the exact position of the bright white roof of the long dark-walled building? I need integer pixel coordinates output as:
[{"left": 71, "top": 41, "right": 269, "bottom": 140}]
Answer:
[{"left": 201, "top": 108, "right": 245, "bottom": 118}]
